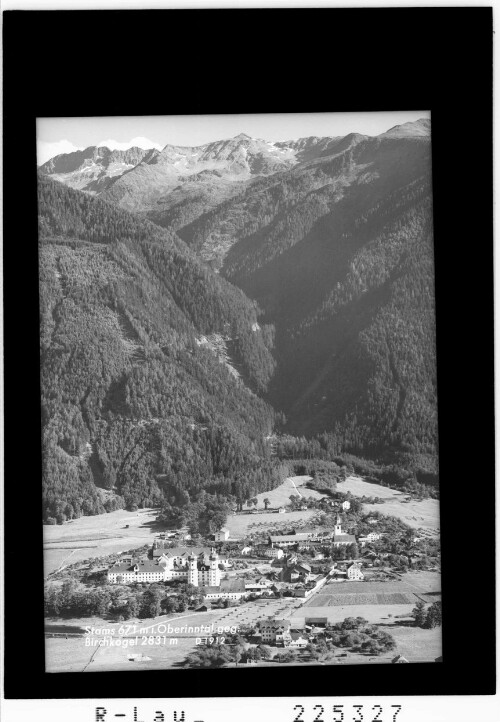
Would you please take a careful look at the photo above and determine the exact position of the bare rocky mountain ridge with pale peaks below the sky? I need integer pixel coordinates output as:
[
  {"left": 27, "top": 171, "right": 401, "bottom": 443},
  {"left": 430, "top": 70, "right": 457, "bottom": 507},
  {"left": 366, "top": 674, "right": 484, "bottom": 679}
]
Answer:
[{"left": 39, "top": 119, "right": 430, "bottom": 204}]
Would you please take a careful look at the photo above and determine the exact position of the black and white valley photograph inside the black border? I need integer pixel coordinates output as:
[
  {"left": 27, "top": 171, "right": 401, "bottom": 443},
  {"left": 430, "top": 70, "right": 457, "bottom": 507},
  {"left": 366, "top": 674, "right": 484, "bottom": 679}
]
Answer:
[{"left": 37, "top": 111, "right": 442, "bottom": 673}]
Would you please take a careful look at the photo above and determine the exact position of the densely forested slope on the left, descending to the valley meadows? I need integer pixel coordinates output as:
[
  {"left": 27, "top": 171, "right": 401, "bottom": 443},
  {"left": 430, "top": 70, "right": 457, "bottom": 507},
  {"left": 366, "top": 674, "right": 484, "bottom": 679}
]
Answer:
[{"left": 39, "top": 176, "right": 286, "bottom": 521}]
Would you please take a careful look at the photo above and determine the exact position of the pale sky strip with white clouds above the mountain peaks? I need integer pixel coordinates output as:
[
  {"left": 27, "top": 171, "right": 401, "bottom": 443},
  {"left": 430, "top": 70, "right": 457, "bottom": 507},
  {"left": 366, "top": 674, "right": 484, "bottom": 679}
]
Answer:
[{"left": 37, "top": 110, "right": 430, "bottom": 165}]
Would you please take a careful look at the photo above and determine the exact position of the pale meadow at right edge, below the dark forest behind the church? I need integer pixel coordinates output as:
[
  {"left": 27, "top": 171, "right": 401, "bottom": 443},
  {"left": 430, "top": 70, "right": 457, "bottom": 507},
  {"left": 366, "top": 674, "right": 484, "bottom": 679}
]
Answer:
[{"left": 337, "top": 476, "right": 439, "bottom": 533}]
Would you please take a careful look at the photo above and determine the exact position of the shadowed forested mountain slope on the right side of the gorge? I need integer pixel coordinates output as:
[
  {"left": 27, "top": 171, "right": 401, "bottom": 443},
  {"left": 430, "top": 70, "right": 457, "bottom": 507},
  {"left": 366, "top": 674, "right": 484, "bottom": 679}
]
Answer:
[{"left": 149, "top": 129, "right": 437, "bottom": 458}]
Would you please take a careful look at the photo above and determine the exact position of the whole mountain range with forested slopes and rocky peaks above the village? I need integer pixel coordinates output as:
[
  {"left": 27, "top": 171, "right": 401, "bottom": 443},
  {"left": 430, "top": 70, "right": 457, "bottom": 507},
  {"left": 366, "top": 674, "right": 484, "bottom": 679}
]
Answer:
[{"left": 39, "top": 119, "right": 437, "bottom": 517}]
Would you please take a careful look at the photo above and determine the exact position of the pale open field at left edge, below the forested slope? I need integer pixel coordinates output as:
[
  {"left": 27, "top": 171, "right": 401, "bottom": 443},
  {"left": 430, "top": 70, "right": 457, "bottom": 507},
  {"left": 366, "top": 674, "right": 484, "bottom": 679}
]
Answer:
[{"left": 43, "top": 509, "right": 160, "bottom": 576}]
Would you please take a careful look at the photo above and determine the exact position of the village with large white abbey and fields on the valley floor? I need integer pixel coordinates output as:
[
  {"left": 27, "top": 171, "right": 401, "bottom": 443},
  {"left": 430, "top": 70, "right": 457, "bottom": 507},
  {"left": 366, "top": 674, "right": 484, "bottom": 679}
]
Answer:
[{"left": 45, "top": 476, "right": 441, "bottom": 671}]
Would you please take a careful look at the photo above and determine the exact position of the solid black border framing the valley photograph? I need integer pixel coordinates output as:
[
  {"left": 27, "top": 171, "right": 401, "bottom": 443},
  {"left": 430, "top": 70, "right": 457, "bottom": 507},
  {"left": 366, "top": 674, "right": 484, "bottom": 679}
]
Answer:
[{"left": 3, "top": 8, "right": 496, "bottom": 699}]
